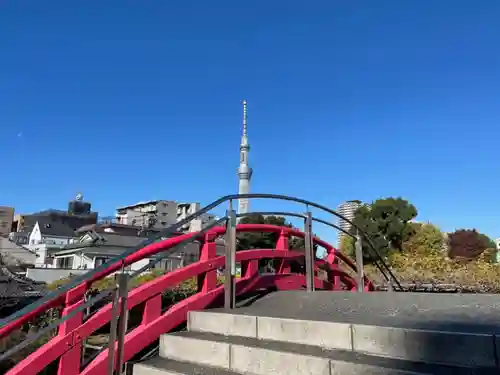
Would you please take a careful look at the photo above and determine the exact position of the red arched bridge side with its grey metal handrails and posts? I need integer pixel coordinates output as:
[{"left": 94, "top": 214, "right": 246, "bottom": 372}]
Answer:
[{"left": 0, "top": 194, "right": 400, "bottom": 375}]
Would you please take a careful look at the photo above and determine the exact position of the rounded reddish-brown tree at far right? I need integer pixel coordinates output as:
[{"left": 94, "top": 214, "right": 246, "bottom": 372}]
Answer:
[{"left": 448, "top": 229, "right": 495, "bottom": 259}]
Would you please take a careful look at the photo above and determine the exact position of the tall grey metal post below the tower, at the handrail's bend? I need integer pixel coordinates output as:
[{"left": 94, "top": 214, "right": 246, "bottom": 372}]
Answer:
[{"left": 224, "top": 200, "right": 236, "bottom": 309}]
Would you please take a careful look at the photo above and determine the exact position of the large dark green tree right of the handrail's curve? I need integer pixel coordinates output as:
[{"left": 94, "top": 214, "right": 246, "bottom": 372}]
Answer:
[{"left": 351, "top": 198, "right": 418, "bottom": 259}]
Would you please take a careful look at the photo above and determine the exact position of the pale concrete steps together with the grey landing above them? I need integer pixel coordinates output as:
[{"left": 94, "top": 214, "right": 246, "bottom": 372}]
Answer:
[{"left": 133, "top": 292, "right": 500, "bottom": 375}]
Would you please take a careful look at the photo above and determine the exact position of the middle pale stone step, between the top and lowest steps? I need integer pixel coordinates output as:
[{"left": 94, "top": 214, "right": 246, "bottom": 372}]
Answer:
[{"left": 160, "top": 331, "right": 498, "bottom": 375}]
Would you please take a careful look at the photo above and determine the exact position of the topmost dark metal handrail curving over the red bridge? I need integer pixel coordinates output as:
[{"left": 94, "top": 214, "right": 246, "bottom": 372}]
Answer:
[{"left": 0, "top": 194, "right": 402, "bottom": 328}]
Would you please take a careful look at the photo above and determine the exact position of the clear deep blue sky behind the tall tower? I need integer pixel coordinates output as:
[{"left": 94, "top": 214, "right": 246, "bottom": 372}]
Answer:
[{"left": 0, "top": 0, "right": 500, "bottom": 241}]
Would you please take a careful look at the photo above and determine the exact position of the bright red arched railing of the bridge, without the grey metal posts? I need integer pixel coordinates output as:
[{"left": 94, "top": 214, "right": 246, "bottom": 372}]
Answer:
[{"left": 0, "top": 224, "right": 373, "bottom": 375}]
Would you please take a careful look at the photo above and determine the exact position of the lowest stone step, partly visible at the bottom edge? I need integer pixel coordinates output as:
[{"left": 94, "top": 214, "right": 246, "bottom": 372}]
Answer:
[{"left": 133, "top": 357, "right": 237, "bottom": 375}]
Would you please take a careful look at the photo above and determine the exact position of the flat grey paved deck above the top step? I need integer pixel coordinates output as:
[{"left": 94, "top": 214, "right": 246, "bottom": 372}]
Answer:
[{"left": 219, "top": 291, "right": 500, "bottom": 333}]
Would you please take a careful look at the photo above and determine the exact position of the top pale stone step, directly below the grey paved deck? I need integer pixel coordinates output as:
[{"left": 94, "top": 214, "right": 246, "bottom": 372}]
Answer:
[{"left": 188, "top": 309, "right": 500, "bottom": 367}]
